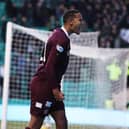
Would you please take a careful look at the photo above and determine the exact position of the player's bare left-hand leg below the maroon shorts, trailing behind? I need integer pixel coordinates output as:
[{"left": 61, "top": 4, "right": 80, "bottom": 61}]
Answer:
[{"left": 25, "top": 115, "right": 43, "bottom": 129}]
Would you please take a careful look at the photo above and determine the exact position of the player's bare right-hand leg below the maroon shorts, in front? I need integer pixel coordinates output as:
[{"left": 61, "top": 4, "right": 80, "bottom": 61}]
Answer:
[{"left": 51, "top": 110, "right": 68, "bottom": 129}]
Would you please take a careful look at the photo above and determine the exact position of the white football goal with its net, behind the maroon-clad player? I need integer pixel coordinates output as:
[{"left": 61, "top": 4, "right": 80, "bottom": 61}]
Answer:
[{"left": 0, "top": 23, "right": 129, "bottom": 129}]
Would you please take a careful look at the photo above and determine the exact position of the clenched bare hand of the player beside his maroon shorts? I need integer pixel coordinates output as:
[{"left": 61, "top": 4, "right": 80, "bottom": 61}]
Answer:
[{"left": 52, "top": 88, "right": 64, "bottom": 101}]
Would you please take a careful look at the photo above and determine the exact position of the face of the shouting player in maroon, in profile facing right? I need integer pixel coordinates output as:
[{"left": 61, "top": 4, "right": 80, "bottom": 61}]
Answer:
[{"left": 71, "top": 13, "right": 83, "bottom": 34}]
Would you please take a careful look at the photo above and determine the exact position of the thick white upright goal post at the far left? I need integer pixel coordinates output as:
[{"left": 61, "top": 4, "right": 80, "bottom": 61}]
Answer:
[{"left": 1, "top": 23, "right": 12, "bottom": 129}]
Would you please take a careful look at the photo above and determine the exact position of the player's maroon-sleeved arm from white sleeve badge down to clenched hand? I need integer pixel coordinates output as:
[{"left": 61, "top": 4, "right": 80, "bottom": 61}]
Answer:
[{"left": 45, "top": 44, "right": 64, "bottom": 100}]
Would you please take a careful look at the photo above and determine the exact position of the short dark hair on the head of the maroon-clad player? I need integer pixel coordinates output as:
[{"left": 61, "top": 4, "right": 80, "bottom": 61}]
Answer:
[{"left": 63, "top": 10, "right": 80, "bottom": 23}]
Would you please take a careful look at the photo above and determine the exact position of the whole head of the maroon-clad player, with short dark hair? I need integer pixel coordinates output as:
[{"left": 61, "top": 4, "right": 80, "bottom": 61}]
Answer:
[{"left": 63, "top": 10, "right": 82, "bottom": 34}]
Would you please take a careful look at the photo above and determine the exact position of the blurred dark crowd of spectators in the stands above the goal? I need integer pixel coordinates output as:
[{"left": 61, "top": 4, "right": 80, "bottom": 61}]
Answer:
[{"left": 1, "top": 0, "right": 129, "bottom": 48}]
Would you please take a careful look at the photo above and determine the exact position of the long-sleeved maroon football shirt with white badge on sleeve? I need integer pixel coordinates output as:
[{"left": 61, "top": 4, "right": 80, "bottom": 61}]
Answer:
[{"left": 36, "top": 29, "right": 70, "bottom": 89}]
